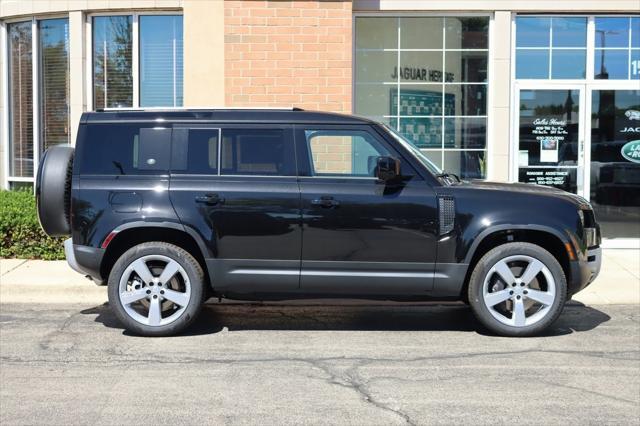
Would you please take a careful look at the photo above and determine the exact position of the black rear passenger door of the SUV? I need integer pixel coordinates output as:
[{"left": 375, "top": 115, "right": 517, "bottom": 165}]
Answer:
[{"left": 171, "top": 126, "right": 302, "bottom": 292}]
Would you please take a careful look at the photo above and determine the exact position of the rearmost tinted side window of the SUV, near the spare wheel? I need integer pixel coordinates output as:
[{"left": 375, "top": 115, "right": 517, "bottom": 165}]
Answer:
[{"left": 80, "top": 124, "right": 171, "bottom": 175}]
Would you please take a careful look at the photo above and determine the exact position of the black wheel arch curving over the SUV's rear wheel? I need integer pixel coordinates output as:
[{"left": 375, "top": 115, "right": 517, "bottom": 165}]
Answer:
[{"left": 100, "top": 222, "right": 210, "bottom": 284}]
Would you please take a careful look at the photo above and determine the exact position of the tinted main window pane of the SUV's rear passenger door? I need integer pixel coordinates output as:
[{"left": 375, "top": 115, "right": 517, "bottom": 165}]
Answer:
[{"left": 221, "top": 129, "right": 296, "bottom": 176}]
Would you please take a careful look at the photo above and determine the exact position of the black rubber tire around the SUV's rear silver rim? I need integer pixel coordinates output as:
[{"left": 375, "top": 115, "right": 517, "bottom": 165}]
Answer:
[{"left": 108, "top": 241, "right": 206, "bottom": 336}]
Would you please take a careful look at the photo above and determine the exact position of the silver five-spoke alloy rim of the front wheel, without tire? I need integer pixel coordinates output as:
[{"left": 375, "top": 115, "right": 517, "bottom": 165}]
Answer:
[{"left": 482, "top": 255, "right": 556, "bottom": 327}]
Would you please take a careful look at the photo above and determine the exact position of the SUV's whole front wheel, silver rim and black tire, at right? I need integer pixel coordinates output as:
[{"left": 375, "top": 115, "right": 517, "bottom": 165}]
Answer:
[{"left": 469, "top": 243, "right": 567, "bottom": 336}]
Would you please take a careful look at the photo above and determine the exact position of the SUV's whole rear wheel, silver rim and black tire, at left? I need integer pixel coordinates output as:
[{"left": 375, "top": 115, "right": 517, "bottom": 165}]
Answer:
[{"left": 108, "top": 242, "right": 205, "bottom": 336}]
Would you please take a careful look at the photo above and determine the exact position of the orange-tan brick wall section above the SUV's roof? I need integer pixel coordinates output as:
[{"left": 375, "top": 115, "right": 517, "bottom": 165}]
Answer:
[{"left": 224, "top": 0, "right": 352, "bottom": 112}]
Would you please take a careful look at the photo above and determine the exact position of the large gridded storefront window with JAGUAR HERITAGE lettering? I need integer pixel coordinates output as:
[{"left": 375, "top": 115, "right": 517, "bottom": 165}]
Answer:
[{"left": 354, "top": 17, "right": 489, "bottom": 178}]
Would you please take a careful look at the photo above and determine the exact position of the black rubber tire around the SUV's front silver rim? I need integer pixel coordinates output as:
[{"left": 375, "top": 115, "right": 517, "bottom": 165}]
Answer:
[{"left": 468, "top": 242, "right": 567, "bottom": 337}]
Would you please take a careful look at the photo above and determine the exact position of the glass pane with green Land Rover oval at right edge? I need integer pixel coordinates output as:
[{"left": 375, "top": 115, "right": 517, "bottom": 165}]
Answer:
[{"left": 590, "top": 90, "right": 640, "bottom": 238}]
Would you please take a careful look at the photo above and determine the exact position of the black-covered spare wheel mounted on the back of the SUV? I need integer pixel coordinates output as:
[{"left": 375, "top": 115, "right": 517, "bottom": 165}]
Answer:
[{"left": 36, "top": 145, "right": 73, "bottom": 237}]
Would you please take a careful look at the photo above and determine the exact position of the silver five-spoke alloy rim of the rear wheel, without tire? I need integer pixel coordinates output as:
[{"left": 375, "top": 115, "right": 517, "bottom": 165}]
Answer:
[{"left": 118, "top": 255, "right": 191, "bottom": 327}]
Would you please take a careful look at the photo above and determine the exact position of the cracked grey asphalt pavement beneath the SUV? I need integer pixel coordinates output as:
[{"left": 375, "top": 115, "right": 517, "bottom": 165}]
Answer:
[{"left": 0, "top": 302, "right": 640, "bottom": 425}]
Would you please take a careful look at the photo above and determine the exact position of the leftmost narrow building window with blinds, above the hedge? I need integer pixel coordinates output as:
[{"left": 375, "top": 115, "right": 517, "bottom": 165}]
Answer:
[{"left": 7, "top": 21, "right": 34, "bottom": 177}]
